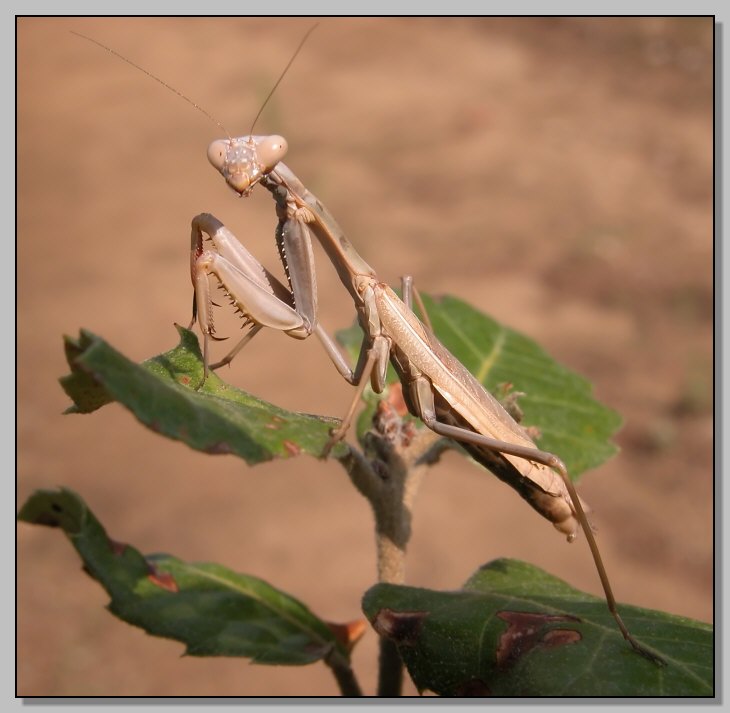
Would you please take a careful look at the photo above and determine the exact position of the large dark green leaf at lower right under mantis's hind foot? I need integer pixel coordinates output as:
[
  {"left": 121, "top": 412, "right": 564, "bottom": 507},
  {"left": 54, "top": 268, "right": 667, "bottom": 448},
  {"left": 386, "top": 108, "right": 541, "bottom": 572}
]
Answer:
[{"left": 363, "top": 559, "right": 714, "bottom": 696}]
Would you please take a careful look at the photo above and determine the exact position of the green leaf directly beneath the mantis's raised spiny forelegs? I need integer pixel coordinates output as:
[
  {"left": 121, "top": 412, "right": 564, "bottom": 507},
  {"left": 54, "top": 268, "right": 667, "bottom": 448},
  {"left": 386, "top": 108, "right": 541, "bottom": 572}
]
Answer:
[{"left": 60, "top": 327, "right": 347, "bottom": 458}]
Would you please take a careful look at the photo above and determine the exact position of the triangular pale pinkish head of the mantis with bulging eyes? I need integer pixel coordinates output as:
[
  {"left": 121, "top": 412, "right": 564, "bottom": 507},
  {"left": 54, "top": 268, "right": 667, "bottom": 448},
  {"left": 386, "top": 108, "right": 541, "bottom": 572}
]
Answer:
[{"left": 208, "top": 135, "right": 289, "bottom": 196}]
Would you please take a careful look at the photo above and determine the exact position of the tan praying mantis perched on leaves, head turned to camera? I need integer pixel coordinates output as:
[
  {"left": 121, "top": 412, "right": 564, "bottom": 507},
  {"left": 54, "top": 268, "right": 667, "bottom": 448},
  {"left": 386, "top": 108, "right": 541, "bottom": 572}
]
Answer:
[{"left": 191, "top": 129, "right": 665, "bottom": 665}]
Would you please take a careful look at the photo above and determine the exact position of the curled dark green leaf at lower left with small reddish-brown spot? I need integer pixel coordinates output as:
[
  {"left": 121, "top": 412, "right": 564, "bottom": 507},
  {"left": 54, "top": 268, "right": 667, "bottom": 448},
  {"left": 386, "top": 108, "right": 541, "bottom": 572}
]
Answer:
[{"left": 18, "top": 488, "right": 349, "bottom": 665}]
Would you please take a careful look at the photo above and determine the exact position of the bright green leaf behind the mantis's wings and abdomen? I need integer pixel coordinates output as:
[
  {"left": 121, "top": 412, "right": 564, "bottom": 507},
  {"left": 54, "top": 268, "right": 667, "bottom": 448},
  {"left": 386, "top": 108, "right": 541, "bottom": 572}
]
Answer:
[{"left": 337, "top": 295, "right": 621, "bottom": 479}]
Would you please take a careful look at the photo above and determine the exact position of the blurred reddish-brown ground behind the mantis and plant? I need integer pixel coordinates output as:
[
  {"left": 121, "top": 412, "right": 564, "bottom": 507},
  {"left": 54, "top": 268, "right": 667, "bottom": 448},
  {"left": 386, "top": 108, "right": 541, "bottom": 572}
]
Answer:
[{"left": 18, "top": 18, "right": 713, "bottom": 695}]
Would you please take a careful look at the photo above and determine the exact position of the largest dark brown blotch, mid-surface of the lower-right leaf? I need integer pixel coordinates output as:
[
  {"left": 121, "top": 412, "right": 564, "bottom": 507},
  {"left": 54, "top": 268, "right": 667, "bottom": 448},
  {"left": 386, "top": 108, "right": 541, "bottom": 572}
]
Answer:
[{"left": 497, "top": 611, "right": 581, "bottom": 670}]
